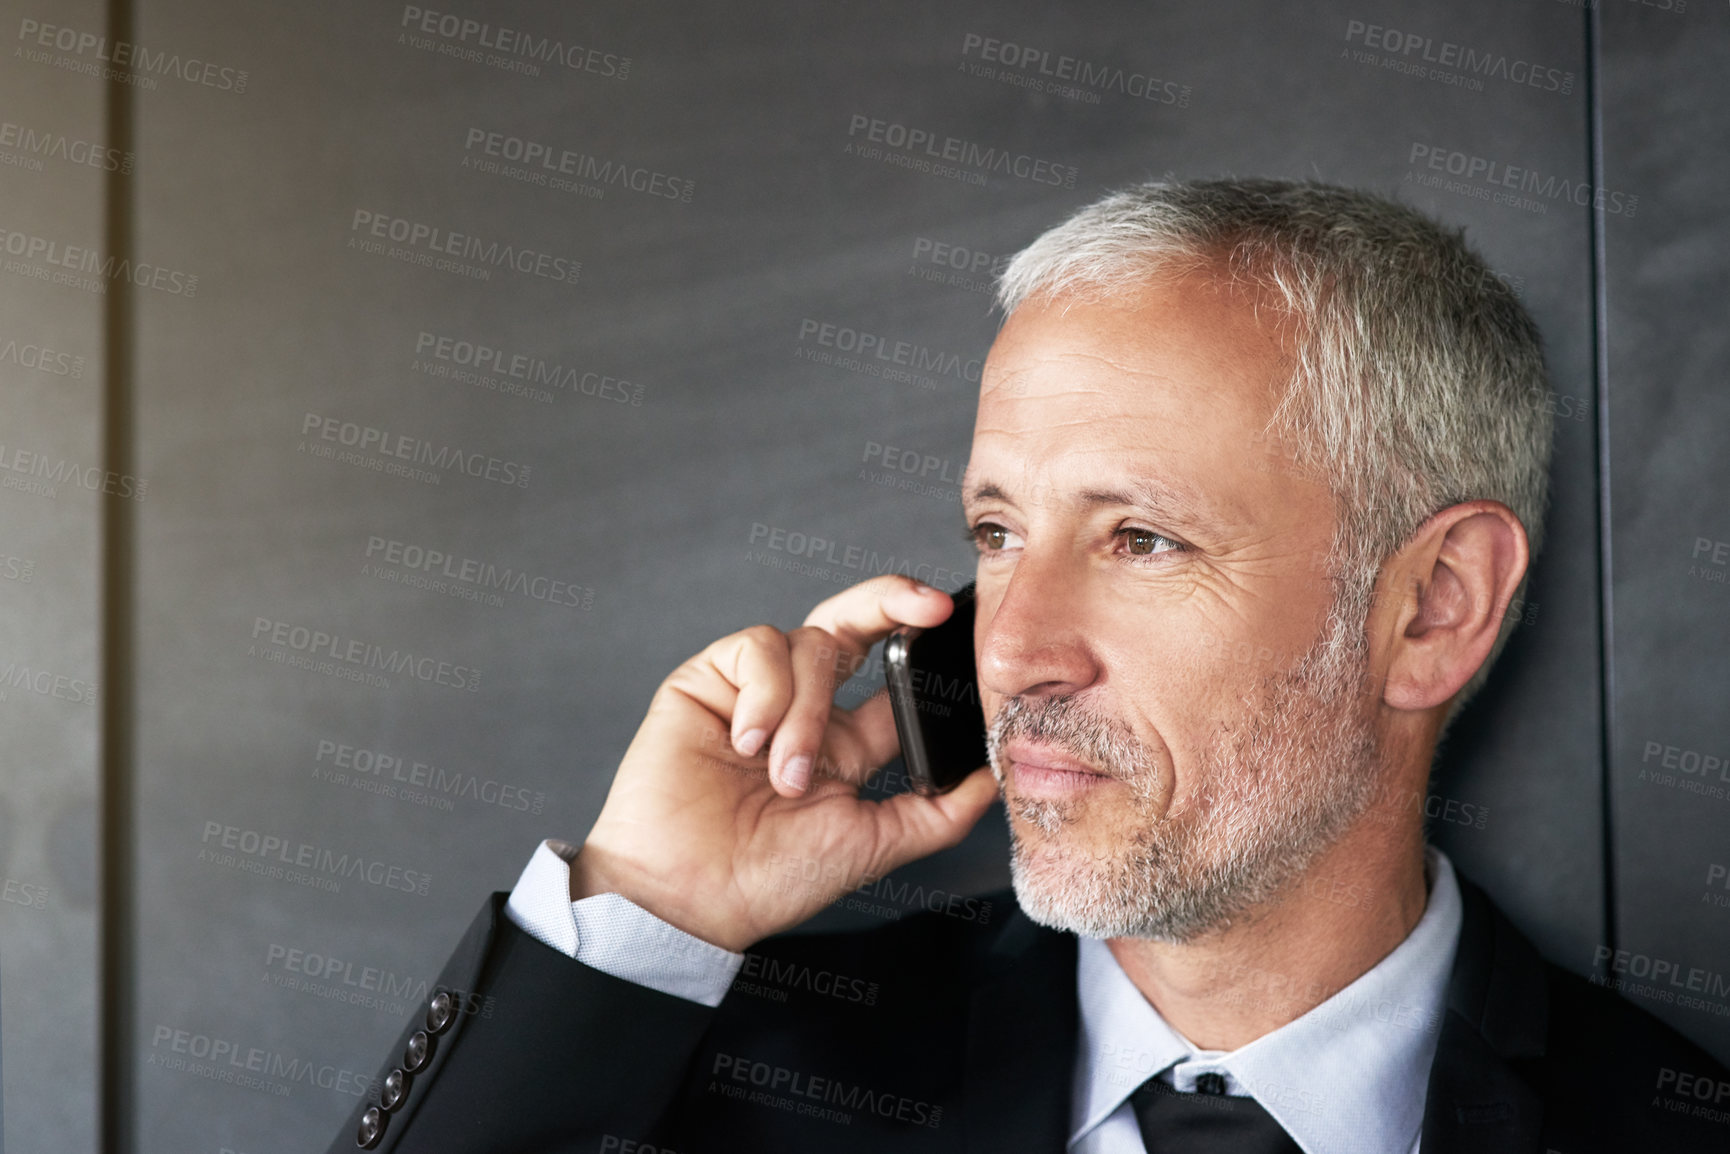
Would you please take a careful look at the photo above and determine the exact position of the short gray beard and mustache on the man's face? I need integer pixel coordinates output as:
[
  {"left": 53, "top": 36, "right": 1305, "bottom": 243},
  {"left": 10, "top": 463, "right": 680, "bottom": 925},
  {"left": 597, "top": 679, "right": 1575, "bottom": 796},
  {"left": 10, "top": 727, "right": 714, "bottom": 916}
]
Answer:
[{"left": 988, "top": 616, "right": 1379, "bottom": 943}]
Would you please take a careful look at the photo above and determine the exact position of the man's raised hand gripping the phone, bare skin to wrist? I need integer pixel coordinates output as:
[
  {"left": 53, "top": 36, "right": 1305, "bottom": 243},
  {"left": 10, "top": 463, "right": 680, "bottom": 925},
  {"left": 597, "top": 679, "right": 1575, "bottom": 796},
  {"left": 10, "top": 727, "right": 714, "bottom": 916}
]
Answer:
[{"left": 571, "top": 576, "right": 996, "bottom": 950}]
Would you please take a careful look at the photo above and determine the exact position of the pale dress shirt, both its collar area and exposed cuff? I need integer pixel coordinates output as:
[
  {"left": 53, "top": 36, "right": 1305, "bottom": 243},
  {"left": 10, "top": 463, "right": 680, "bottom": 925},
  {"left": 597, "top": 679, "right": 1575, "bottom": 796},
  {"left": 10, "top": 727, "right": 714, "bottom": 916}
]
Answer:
[{"left": 505, "top": 841, "right": 1462, "bottom": 1154}]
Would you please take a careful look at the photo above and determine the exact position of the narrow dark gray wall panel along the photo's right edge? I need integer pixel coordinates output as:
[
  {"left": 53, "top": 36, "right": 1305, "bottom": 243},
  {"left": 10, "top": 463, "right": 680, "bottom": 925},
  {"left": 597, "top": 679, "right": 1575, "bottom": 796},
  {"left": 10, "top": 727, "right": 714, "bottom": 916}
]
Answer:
[{"left": 1591, "top": 7, "right": 1730, "bottom": 1055}]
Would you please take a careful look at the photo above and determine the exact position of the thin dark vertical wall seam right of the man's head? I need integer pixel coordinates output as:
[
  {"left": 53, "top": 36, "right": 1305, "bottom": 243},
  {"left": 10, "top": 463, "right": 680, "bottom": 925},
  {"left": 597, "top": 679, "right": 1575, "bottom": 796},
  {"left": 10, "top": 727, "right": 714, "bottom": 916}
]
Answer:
[{"left": 1585, "top": 3, "right": 1621, "bottom": 950}]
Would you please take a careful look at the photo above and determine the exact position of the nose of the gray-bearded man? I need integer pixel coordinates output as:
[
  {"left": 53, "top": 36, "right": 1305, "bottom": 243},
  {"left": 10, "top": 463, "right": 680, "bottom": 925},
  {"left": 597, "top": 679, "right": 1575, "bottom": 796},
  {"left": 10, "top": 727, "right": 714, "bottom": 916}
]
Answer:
[{"left": 979, "top": 554, "right": 1099, "bottom": 697}]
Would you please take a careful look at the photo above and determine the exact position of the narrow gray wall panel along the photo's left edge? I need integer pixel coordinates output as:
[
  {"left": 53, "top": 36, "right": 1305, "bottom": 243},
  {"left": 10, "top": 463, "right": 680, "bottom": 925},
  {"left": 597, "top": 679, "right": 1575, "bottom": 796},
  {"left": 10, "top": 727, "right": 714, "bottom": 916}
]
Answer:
[{"left": 0, "top": 0, "right": 107, "bottom": 1151}]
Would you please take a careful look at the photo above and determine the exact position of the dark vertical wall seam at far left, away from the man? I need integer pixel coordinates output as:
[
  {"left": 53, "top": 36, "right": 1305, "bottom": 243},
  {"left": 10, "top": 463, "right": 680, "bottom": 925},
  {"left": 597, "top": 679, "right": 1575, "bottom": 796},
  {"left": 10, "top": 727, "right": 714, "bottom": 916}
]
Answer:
[{"left": 95, "top": 0, "right": 137, "bottom": 1154}]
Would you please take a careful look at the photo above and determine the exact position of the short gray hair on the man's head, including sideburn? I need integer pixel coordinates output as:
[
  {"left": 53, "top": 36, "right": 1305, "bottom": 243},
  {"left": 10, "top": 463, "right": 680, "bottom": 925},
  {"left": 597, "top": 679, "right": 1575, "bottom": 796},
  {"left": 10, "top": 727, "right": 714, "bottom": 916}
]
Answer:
[{"left": 998, "top": 180, "right": 1552, "bottom": 720}]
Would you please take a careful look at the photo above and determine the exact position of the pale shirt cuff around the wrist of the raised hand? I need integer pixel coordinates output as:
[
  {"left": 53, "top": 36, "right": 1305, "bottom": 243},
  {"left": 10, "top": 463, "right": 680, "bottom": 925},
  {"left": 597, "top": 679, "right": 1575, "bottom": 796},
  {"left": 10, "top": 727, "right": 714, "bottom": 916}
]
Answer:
[{"left": 505, "top": 839, "right": 746, "bottom": 1007}]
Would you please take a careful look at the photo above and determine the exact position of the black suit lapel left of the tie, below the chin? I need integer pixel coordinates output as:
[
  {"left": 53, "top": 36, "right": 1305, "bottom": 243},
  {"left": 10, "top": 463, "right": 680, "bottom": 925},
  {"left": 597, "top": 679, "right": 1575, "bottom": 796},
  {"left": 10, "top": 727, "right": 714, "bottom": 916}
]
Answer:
[{"left": 964, "top": 910, "right": 1080, "bottom": 1154}]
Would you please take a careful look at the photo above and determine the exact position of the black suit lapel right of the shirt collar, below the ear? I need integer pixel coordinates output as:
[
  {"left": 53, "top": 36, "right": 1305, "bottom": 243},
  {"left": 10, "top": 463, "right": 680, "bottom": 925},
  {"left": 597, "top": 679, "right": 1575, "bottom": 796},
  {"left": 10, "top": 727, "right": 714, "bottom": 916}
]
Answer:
[{"left": 1420, "top": 879, "right": 1548, "bottom": 1154}]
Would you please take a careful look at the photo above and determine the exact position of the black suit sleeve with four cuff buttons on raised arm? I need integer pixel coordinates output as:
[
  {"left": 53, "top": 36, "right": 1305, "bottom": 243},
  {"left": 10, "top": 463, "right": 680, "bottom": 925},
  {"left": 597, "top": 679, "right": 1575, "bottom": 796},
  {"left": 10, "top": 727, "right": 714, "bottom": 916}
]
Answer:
[{"left": 330, "top": 893, "right": 714, "bottom": 1154}]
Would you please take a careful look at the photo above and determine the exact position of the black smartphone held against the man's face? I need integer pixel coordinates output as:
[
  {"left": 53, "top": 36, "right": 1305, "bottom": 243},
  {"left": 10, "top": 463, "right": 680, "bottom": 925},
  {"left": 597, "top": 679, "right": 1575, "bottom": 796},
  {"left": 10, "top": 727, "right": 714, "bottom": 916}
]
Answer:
[{"left": 882, "top": 583, "right": 986, "bottom": 796}]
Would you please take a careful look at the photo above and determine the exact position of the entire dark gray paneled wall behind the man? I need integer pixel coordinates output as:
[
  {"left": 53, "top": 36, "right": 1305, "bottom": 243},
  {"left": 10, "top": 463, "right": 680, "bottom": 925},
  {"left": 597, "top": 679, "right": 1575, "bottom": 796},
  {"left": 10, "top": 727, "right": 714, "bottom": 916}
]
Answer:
[{"left": 0, "top": 0, "right": 1730, "bottom": 1154}]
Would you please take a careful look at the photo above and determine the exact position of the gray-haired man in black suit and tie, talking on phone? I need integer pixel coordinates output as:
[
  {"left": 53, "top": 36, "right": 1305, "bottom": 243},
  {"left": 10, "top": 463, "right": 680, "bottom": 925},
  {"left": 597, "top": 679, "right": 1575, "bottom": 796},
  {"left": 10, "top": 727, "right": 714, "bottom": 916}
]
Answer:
[{"left": 332, "top": 182, "right": 1730, "bottom": 1154}]
